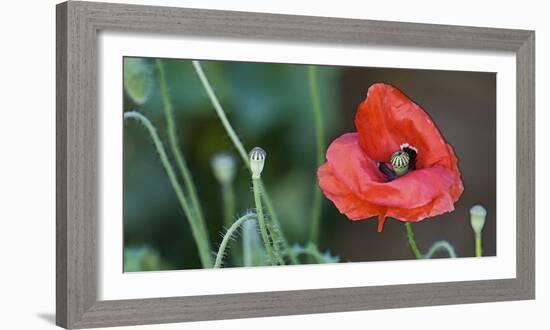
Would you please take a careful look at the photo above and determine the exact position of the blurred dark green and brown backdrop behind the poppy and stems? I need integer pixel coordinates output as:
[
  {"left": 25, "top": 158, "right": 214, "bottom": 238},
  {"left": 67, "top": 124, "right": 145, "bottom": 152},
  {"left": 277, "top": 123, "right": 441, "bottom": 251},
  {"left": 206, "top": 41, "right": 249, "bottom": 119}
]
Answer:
[{"left": 123, "top": 57, "right": 496, "bottom": 271}]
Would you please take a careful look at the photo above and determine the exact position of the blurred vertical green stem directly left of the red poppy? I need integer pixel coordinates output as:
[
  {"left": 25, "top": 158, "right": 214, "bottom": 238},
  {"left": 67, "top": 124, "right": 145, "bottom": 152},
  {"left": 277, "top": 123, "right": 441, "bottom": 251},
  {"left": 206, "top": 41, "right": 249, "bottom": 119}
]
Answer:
[{"left": 308, "top": 65, "right": 326, "bottom": 243}]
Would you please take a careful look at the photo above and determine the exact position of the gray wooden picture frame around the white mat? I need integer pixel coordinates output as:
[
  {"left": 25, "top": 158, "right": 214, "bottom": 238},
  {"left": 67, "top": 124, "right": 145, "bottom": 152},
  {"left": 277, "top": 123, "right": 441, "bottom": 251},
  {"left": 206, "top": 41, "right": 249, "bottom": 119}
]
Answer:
[{"left": 56, "top": 1, "right": 535, "bottom": 328}]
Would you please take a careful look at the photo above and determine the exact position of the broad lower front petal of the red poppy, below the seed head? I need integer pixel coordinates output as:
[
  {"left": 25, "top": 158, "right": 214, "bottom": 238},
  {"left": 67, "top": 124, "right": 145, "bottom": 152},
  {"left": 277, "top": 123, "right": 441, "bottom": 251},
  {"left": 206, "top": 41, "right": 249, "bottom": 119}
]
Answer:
[{"left": 318, "top": 133, "right": 463, "bottom": 230}]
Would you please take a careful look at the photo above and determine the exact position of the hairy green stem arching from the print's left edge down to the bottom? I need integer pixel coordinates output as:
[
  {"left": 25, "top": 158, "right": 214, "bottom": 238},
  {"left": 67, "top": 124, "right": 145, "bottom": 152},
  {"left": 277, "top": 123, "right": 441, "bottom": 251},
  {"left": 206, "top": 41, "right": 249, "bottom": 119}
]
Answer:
[{"left": 124, "top": 111, "right": 212, "bottom": 268}]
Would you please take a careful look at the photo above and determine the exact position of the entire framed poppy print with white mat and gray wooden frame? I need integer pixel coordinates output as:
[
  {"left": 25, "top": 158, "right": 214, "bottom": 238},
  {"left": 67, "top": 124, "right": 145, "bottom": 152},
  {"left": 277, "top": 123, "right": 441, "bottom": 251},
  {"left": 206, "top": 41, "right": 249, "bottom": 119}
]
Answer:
[{"left": 56, "top": 1, "right": 535, "bottom": 328}]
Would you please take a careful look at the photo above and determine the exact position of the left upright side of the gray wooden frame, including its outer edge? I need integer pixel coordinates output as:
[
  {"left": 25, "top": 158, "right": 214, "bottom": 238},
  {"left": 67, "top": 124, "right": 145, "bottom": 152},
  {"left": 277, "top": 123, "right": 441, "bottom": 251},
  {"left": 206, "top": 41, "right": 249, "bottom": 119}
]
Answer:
[{"left": 56, "top": 3, "right": 99, "bottom": 328}]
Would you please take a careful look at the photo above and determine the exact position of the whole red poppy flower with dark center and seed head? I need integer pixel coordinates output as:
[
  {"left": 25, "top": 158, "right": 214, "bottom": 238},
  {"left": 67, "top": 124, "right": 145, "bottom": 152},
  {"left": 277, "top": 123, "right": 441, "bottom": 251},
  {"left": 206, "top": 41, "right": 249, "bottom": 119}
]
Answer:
[{"left": 317, "top": 83, "right": 464, "bottom": 232}]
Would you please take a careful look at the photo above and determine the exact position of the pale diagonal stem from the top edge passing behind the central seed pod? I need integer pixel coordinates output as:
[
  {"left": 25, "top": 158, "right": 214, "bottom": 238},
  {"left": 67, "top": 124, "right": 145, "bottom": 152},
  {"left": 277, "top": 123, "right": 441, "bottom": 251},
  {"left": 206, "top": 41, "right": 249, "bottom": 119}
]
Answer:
[{"left": 193, "top": 61, "right": 298, "bottom": 264}]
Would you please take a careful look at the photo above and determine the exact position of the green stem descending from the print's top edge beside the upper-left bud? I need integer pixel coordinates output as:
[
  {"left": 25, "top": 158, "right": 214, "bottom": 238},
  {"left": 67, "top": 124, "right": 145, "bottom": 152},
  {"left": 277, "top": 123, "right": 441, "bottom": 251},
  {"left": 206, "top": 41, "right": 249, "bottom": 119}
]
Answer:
[{"left": 156, "top": 59, "right": 215, "bottom": 266}]
